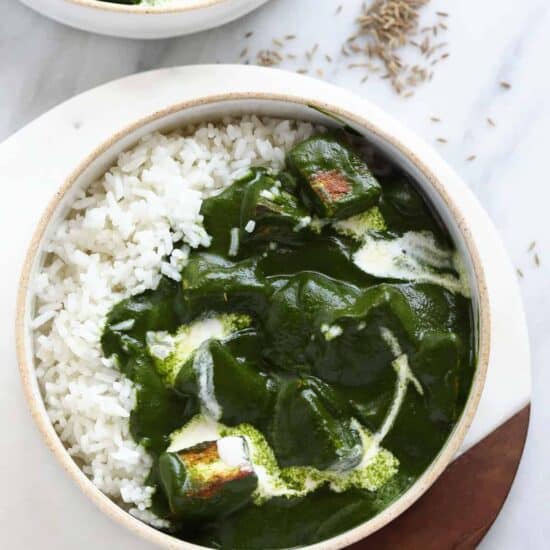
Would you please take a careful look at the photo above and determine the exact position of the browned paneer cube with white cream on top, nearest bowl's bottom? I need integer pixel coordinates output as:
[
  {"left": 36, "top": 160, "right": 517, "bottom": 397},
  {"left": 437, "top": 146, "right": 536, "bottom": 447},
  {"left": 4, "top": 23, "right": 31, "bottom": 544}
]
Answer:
[{"left": 158, "top": 436, "right": 258, "bottom": 521}]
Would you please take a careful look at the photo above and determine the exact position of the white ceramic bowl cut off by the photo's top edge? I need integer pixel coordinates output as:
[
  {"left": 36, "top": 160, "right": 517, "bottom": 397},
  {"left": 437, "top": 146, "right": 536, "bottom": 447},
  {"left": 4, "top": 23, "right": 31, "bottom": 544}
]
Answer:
[{"left": 21, "top": 0, "right": 267, "bottom": 39}]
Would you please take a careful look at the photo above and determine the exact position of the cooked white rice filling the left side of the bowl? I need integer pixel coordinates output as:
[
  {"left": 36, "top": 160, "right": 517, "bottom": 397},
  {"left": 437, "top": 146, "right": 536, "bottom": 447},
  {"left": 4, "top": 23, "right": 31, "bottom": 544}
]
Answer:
[{"left": 32, "top": 116, "right": 314, "bottom": 526}]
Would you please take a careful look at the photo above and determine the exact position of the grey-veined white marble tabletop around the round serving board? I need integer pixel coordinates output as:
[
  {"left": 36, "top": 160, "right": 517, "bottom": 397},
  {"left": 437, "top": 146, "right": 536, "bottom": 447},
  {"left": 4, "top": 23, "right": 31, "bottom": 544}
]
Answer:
[{"left": 0, "top": 0, "right": 550, "bottom": 549}]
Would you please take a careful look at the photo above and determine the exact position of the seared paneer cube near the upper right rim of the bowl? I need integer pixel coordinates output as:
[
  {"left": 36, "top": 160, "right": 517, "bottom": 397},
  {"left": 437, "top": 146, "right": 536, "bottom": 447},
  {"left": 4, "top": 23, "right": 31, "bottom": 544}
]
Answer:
[{"left": 288, "top": 136, "right": 381, "bottom": 219}]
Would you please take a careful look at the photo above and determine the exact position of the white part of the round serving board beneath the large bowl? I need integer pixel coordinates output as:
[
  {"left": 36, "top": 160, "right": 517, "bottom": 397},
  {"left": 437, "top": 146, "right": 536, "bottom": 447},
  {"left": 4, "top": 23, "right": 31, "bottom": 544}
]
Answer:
[{"left": 0, "top": 65, "right": 531, "bottom": 550}]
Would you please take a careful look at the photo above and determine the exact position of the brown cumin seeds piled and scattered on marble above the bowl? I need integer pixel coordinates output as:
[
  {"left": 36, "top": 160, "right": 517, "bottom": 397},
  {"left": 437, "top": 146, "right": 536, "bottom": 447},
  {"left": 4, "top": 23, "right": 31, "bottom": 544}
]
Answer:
[{"left": 244, "top": 0, "right": 450, "bottom": 97}]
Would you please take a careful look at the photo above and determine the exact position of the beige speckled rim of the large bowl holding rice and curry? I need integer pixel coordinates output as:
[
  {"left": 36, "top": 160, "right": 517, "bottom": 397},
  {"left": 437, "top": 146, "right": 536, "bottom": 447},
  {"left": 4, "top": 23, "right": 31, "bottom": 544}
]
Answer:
[{"left": 15, "top": 90, "right": 491, "bottom": 550}]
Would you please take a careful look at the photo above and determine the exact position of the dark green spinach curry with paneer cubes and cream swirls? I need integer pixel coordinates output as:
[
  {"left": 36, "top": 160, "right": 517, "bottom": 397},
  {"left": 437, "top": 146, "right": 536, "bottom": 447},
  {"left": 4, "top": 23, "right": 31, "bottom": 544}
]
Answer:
[{"left": 102, "top": 133, "right": 475, "bottom": 549}]
